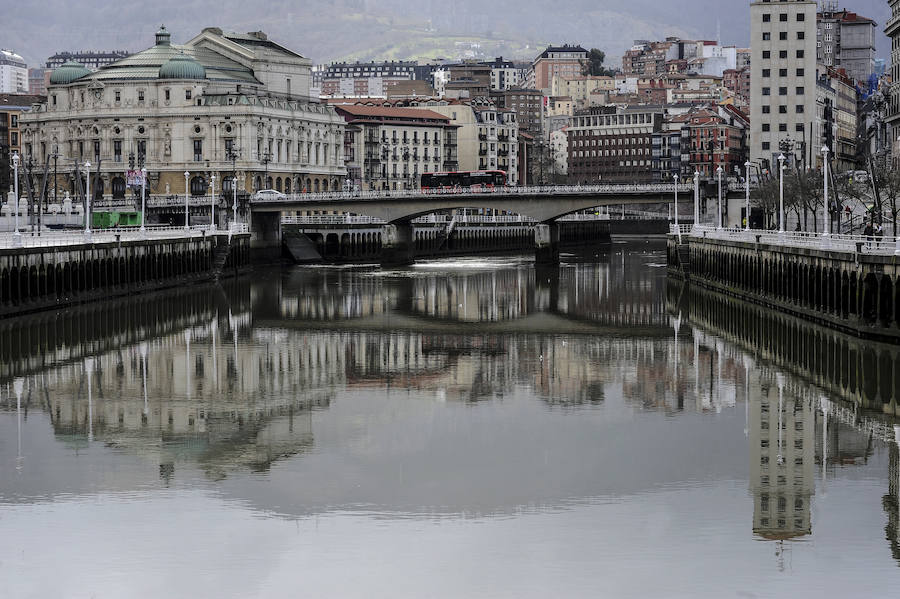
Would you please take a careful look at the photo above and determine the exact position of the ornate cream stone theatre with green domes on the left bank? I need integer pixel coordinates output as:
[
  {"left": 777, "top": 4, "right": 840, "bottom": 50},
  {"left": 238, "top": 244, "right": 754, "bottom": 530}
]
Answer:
[{"left": 22, "top": 27, "right": 346, "bottom": 205}]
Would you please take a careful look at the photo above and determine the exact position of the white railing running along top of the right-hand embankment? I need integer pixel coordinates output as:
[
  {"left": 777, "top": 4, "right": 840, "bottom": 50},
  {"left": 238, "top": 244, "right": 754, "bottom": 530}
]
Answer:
[{"left": 673, "top": 225, "right": 900, "bottom": 255}]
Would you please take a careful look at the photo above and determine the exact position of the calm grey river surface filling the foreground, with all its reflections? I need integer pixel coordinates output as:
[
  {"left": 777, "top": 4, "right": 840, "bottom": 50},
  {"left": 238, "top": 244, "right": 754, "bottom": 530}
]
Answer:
[{"left": 0, "top": 244, "right": 900, "bottom": 598}]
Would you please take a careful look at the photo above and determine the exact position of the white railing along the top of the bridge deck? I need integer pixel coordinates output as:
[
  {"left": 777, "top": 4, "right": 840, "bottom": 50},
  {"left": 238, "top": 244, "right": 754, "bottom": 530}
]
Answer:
[{"left": 256, "top": 183, "right": 694, "bottom": 205}]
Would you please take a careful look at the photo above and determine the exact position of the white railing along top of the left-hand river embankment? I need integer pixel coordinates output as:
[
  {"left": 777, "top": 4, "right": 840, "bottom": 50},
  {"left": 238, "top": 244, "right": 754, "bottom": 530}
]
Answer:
[{"left": 0, "top": 223, "right": 243, "bottom": 249}]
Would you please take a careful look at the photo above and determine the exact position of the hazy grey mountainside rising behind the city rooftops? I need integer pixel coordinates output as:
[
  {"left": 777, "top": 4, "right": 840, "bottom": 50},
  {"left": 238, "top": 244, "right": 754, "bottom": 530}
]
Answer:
[{"left": 0, "top": 0, "right": 890, "bottom": 71}]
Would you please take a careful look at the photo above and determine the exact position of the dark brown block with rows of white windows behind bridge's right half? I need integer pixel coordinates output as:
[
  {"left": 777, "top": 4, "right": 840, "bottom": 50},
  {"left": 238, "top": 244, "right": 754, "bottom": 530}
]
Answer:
[{"left": 567, "top": 105, "right": 664, "bottom": 183}]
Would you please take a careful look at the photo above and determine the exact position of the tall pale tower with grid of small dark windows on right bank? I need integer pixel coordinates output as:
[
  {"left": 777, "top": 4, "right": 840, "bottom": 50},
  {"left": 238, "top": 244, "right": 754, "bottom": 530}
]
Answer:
[{"left": 750, "top": 0, "right": 821, "bottom": 172}]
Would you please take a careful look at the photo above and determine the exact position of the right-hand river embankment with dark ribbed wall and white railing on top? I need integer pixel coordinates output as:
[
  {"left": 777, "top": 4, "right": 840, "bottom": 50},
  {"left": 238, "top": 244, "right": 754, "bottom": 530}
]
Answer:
[{"left": 667, "top": 225, "right": 900, "bottom": 340}]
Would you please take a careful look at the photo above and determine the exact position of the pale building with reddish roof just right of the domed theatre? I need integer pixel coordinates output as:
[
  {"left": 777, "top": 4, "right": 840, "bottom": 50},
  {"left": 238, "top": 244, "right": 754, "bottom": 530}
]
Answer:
[{"left": 335, "top": 104, "right": 459, "bottom": 190}]
